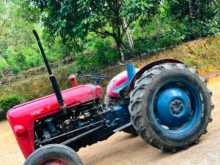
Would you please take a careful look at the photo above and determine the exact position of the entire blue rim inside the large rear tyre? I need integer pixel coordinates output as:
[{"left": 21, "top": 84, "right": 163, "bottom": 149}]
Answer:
[{"left": 151, "top": 79, "right": 203, "bottom": 139}]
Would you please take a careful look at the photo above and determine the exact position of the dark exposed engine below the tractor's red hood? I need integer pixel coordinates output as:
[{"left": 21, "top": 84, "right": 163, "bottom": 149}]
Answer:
[{"left": 34, "top": 100, "right": 104, "bottom": 150}]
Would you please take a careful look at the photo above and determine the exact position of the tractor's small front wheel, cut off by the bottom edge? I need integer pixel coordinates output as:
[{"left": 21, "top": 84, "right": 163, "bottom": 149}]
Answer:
[{"left": 24, "top": 144, "right": 83, "bottom": 165}]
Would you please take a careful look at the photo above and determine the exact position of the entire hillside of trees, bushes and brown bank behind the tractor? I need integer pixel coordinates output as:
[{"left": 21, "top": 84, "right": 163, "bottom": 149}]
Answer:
[{"left": 0, "top": 0, "right": 220, "bottom": 120}]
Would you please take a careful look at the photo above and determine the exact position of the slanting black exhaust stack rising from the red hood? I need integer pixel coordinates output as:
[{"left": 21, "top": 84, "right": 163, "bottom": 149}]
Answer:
[{"left": 33, "top": 30, "right": 66, "bottom": 112}]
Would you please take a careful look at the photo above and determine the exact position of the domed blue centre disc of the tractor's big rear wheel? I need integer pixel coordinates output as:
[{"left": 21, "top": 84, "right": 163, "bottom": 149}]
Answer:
[{"left": 156, "top": 88, "right": 192, "bottom": 128}]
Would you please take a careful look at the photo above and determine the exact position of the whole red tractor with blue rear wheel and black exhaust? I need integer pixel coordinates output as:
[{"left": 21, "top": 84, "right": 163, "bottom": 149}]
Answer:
[{"left": 7, "top": 31, "right": 214, "bottom": 165}]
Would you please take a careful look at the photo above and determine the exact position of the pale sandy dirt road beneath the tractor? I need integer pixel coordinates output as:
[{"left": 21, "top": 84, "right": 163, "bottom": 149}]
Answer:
[{"left": 0, "top": 80, "right": 220, "bottom": 165}]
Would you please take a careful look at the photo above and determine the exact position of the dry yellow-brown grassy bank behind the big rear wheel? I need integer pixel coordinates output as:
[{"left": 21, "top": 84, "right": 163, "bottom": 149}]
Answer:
[{"left": 131, "top": 36, "right": 220, "bottom": 75}]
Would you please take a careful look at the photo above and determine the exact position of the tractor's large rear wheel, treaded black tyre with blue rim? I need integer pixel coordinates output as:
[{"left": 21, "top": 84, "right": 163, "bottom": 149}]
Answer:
[{"left": 129, "top": 63, "right": 214, "bottom": 152}]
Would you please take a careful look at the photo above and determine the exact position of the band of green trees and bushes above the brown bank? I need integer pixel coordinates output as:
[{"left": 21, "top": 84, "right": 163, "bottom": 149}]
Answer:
[{"left": 0, "top": 0, "right": 220, "bottom": 77}]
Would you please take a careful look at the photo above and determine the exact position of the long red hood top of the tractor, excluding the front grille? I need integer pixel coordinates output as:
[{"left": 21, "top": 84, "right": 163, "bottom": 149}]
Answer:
[{"left": 7, "top": 85, "right": 101, "bottom": 122}]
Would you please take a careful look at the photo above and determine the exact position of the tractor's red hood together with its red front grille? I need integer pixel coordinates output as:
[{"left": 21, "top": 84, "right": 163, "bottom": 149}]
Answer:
[{"left": 7, "top": 85, "right": 101, "bottom": 158}]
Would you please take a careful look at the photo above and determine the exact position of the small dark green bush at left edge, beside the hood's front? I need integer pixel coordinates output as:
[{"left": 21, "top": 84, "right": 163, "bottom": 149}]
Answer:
[{"left": 0, "top": 95, "right": 23, "bottom": 120}]
